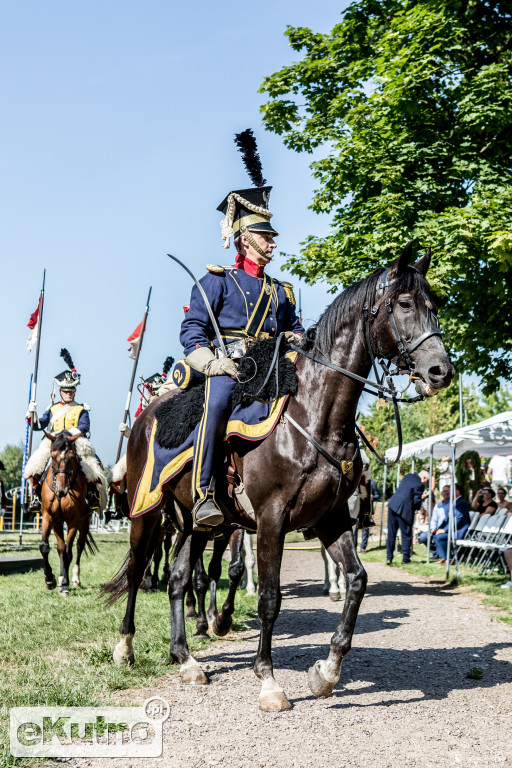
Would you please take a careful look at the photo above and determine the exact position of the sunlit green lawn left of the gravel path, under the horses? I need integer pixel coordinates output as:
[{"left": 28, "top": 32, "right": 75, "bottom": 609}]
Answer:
[{"left": 0, "top": 534, "right": 256, "bottom": 768}]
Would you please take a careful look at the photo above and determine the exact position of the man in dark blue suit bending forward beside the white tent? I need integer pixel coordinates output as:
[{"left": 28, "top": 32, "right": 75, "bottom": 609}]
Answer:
[{"left": 386, "top": 472, "right": 429, "bottom": 565}]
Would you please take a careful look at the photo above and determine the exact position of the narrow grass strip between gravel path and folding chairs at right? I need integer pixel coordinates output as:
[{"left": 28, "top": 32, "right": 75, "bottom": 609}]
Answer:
[{"left": 361, "top": 534, "right": 512, "bottom": 625}]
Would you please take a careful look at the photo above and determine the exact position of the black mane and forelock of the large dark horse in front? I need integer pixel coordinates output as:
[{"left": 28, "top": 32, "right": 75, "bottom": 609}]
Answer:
[{"left": 302, "top": 267, "right": 424, "bottom": 355}]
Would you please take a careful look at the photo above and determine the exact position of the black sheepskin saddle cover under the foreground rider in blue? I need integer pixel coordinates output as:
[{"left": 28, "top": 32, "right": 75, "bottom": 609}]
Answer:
[{"left": 155, "top": 339, "right": 299, "bottom": 449}]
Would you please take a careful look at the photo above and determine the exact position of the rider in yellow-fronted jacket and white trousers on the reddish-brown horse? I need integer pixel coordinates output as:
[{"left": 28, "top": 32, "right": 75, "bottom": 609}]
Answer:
[{"left": 25, "top": 349, "right": 107, "bottom": 510}]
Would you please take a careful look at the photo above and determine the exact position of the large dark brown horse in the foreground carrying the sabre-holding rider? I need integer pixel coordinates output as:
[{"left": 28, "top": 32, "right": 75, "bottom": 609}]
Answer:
[{"left": 106, "top": 243, "right": 454, "bottom": 711}]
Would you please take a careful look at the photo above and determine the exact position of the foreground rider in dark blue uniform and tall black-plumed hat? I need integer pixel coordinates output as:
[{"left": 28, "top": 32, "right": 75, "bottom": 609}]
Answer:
[{"left": 180, "top": 130, "right": 304, "bottom": 528}]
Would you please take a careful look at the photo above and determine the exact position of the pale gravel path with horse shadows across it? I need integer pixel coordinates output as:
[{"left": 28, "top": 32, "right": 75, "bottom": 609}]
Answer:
[{"left": 72, "top": 551, "right": 512, "bottom": 768}]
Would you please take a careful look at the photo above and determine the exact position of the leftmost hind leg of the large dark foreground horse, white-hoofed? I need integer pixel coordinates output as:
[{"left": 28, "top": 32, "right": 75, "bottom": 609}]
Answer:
[{"left": 113, "top": 511, "right": 160, "bottom": 667}]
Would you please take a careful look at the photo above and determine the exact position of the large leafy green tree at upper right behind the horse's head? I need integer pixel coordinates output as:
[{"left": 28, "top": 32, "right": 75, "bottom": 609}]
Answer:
[{"left": 261, "top": 0, "right": 512, "bottom": 391}]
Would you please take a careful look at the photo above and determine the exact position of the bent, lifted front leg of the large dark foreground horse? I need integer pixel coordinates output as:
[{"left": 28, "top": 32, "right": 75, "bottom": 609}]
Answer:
[{"left": 308, "top": 523, "right": 367, "bottom": 698}]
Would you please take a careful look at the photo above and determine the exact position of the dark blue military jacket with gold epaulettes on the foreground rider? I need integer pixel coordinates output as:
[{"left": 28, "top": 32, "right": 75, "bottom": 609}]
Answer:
[{"left": 180, "top": 266, "right": 304, "bottom": 355}]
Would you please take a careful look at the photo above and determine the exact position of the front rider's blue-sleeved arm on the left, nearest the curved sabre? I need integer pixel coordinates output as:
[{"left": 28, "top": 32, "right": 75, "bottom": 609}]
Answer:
[{"left": 180, "top": 273, "right": 225, "bottom": 355}]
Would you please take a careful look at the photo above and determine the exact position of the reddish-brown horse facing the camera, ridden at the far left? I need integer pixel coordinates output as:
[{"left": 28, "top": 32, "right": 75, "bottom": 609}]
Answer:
[{"left": 39, "top": 431, "right": 97, "bottom": 596}]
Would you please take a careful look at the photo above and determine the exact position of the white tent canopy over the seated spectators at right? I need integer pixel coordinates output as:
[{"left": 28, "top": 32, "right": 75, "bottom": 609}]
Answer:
[{"left": 384, "top": 411, "right": 512, "bottom": 461}]
